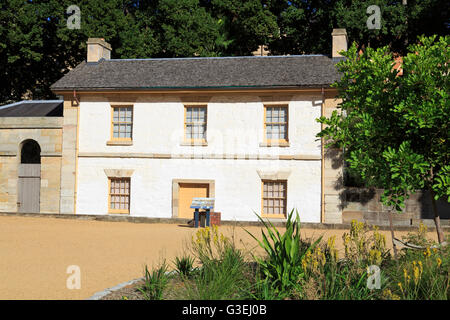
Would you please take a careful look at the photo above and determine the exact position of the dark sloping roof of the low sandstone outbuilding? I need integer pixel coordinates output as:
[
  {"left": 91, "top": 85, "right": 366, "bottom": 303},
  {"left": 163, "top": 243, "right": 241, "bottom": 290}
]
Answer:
[{"left": 0, "top": 100, "right": 63, "bottom": 117}]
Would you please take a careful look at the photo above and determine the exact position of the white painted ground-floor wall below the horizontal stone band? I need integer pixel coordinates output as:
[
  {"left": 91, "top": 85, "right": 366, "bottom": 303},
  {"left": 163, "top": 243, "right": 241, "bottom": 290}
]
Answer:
[{"left": 77, "top": 158, "right": 321, "bottom": 222}]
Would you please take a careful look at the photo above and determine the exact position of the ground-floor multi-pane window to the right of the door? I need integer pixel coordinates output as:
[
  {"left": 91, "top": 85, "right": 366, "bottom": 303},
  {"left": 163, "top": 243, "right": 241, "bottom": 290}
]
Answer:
[{"left": 262, "top": 180, "right": 287, "bottom": 217}]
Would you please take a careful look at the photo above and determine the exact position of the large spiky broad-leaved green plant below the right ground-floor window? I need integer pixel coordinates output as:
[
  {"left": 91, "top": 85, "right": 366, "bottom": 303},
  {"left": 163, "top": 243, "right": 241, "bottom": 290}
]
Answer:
[{"left": 247, "top": 210, "right": 321, "bottom": 291}]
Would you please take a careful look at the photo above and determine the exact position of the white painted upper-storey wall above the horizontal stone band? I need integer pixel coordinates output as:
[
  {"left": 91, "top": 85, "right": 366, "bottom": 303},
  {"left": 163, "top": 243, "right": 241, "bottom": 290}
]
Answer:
[{"left": 79, "top": 95, "right": 321, "bottom": 156}]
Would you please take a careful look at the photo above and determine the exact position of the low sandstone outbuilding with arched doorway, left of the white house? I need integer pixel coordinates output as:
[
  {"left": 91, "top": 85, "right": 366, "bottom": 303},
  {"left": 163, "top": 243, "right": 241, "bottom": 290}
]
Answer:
[{"left": 0, "top": 100, "right": 63, "bottom": 213}]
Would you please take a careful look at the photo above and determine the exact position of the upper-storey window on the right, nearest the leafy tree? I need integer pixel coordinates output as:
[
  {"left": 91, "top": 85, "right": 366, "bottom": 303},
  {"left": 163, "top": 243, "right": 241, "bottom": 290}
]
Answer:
[{"left": 264, "top": 106, "right": 288, "bottom": 142}]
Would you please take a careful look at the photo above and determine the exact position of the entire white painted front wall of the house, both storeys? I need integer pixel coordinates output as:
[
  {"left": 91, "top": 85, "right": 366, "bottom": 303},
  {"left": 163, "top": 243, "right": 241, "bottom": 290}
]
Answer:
[{"left": 77, "top": 95, "right": 321, "bottom": 222}]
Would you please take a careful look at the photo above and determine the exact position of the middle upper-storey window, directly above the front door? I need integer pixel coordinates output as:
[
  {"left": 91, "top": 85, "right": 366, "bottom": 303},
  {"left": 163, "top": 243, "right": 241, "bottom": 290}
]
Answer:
[{"left": 184, "top": 106, "right": 206, "bottom": 142}]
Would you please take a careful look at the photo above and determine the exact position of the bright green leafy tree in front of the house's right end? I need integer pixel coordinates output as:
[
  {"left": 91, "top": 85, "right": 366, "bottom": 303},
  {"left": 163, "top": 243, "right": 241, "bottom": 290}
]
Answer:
[{"left": 318, "top": 36, "right": 450, "bottom": 242}]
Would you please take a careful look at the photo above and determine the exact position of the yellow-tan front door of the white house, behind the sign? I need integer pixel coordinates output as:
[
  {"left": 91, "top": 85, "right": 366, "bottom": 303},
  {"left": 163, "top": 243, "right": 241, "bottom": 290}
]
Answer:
[{"left": 178, "top": 183, "right": 209, "bottom": 219}]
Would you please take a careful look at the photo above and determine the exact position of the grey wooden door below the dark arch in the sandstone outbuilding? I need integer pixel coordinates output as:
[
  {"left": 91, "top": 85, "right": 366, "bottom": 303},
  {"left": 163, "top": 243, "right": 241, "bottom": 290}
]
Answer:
[{"left": 17, "top": 163, "right": 41, "bottom": 213}]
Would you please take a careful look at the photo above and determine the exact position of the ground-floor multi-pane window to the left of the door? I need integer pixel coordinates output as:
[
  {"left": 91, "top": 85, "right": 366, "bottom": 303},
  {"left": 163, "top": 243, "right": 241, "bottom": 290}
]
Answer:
[{"left": 109, "top": 178, "right": 130, "bottom": 213}]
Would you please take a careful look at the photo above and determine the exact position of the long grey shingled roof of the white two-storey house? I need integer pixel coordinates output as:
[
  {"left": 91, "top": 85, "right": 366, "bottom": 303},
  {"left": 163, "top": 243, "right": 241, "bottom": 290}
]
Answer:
[{"left": 51, "top": 55, "right": 338, "bottom": 90}]
